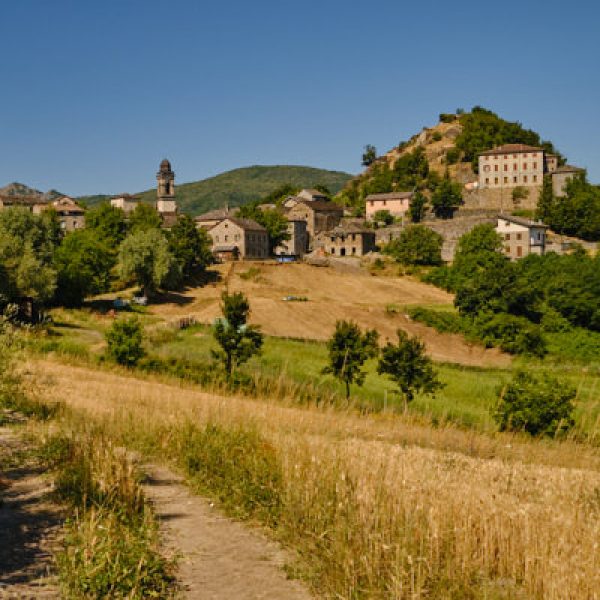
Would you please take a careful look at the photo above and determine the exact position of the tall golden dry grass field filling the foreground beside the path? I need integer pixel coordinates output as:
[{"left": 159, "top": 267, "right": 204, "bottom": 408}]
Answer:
[{"left": 30, "top": 361, "right": 600, "bottom": 600}]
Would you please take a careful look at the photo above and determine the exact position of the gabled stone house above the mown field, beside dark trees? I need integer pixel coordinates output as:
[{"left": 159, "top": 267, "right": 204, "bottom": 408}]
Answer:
[{"left": 208, "top": 217, "right": 269, "bottom": 259}]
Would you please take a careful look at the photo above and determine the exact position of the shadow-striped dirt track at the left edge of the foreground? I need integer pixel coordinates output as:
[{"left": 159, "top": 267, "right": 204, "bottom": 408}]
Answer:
[{"left": 0, "top": 427, "right": 63, "bottom": 599}]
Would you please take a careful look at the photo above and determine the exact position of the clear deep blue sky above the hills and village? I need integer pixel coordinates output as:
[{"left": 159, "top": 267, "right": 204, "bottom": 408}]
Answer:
[{"left": 0, "top": 0, "right": 600, "bottom": 195}]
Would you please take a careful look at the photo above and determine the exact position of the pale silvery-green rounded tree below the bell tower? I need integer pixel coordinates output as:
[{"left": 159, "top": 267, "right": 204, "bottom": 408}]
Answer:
[{"left": 117, "top": 229, "right": 181, "bottom": 297}]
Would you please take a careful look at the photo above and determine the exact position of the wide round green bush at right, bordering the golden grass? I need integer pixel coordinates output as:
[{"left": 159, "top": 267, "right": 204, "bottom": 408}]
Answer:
[{"left": 494, "top": 372, "right": 576, "bottom": 437}]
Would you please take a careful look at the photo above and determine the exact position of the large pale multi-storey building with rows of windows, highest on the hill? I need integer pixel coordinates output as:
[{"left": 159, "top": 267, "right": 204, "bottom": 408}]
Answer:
[{"left": 479, "top": 144, "right": 558, "bottom": 189}]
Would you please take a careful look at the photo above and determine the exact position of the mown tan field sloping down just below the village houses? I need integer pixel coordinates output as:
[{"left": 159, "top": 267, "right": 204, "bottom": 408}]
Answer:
[{"left": 151, "top": 263, "right": 510, "bottom": 367}]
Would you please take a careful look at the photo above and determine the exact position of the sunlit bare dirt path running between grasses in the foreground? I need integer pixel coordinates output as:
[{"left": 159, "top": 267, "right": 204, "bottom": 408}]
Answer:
[{"left": 144, "top": 466, "right": 311, "bottom": 600}]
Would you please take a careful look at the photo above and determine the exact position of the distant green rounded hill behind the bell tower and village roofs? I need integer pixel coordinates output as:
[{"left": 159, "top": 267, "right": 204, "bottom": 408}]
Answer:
[{"left": 80, "top": 165, "right": 352, "bottom": 215}]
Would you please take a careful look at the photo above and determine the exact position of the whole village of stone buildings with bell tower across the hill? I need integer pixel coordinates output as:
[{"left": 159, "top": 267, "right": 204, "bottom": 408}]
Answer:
[{"left": 0, "top": 132, "right": 584, "bottom": 262}]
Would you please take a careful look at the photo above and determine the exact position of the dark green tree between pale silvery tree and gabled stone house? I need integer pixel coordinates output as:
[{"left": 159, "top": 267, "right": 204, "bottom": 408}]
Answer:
[{"left": 167, "top": 215, "right": 213, "bottom": 279}]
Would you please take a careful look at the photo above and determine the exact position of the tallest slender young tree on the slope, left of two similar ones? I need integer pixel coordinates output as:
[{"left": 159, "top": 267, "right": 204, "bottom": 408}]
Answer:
[{"left": 212, "top": 292, "right": 263, "bottom": 377}]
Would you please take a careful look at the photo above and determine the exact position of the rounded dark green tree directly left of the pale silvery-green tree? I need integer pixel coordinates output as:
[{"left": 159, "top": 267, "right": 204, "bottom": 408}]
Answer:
[{"left": 54, "top": 229, "right": 115, "bottom": 306}]
